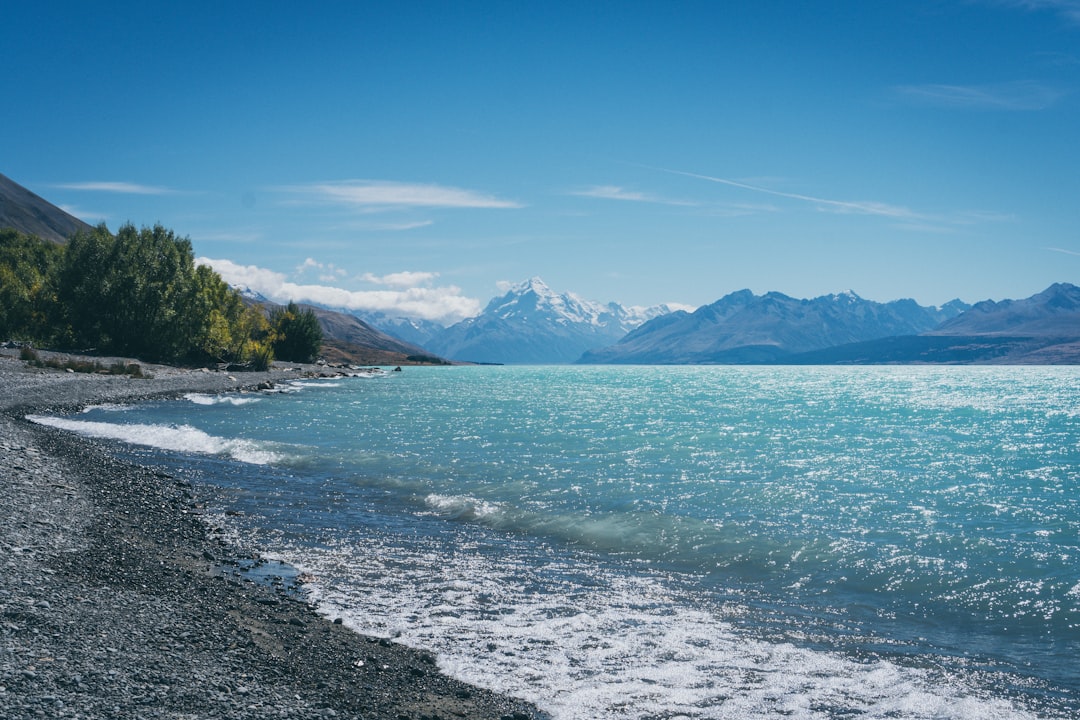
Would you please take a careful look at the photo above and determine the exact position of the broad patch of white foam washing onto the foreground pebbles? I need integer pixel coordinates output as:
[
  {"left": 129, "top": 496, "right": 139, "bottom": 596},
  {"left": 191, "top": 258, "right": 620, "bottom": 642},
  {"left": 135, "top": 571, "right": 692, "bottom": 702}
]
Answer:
[{"left": 286, "top": 537, "right": 1037, "bottom": 720}]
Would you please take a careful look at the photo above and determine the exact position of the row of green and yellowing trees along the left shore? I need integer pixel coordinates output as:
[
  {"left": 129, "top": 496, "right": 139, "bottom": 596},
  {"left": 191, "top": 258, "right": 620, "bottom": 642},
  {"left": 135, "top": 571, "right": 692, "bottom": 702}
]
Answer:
[{"left": 0, "top": 223, "right": 323, "bottom": 369}]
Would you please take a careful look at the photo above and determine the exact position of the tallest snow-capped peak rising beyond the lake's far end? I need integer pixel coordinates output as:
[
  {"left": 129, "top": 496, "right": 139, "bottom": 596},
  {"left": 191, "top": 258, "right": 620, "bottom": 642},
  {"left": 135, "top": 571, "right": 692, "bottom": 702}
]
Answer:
[{"left": 424, "top": 277, "right": 671, "bottom": 364}]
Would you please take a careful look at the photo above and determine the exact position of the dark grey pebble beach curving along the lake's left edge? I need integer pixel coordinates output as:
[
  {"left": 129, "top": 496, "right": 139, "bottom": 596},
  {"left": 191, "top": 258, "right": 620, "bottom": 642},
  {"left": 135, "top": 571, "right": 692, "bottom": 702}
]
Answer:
[{"left": 0, "top": 353, "right": 545, "bottom": 720}]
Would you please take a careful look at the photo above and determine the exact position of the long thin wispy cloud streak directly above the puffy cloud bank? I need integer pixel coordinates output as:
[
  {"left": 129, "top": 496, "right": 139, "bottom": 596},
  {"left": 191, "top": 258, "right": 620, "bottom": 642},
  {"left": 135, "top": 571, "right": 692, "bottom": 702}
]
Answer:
[{"left": 276, "top": 180, "right": 522, "bottom": 210}]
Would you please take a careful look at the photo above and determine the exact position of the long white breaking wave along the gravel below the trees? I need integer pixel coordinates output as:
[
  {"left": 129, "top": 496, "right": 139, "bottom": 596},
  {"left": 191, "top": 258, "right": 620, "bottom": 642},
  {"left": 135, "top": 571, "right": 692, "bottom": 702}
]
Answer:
[{"left": 27, "top": 415, "right": 283, "bottom": 465}]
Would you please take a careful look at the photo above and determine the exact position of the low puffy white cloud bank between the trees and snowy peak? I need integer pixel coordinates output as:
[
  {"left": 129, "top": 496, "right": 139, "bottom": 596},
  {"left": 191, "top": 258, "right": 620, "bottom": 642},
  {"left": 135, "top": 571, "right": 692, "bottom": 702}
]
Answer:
[{"left": 195, "top": 258, "right": 481, "bottom": 324}]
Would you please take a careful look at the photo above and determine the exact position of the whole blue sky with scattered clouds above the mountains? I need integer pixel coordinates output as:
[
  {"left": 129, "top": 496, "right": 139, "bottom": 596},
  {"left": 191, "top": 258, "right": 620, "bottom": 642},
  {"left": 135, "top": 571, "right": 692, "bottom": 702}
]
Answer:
[{"left": 0, "top": 0, "right": 1080, "bottom": 321}]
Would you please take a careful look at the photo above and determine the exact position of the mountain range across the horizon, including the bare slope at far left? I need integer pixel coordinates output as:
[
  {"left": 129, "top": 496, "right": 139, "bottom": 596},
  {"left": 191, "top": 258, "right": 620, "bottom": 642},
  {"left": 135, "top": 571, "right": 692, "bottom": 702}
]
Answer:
[{"left": 0, "top": 175, "right": 1080, "bottom": 364}]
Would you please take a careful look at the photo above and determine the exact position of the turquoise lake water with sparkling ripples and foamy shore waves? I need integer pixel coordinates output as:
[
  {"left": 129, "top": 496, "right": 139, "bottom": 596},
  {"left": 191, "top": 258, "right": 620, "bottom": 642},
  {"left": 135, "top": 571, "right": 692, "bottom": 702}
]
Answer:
[{"left": 33, "top": 367, "right": 1080, "bottom": 718}]
